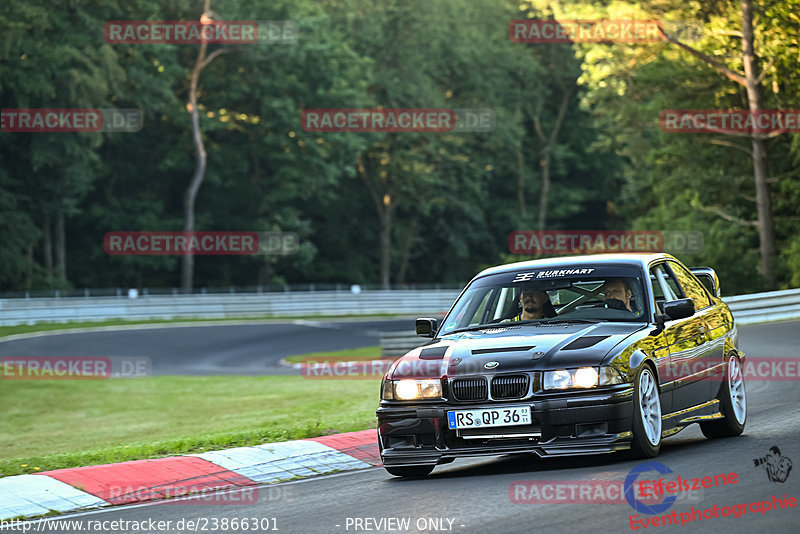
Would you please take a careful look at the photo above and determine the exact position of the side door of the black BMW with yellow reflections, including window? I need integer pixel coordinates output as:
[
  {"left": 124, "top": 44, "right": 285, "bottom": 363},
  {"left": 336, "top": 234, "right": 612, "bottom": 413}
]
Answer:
[{"left": 650, "top": 262, "right": 710, "bottom": 412}]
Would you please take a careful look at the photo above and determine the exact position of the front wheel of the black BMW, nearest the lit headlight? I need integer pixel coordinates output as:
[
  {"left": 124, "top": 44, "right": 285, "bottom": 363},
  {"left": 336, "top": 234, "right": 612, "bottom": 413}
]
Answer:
[{"left": 631, "top": 365, "right": 661, "bottom": 458}]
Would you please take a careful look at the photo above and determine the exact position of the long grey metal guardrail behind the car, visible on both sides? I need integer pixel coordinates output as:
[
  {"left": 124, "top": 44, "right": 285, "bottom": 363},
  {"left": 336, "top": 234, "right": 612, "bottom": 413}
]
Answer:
[{"left": 0, "top": 289, "right": 800, "bottom": 326}]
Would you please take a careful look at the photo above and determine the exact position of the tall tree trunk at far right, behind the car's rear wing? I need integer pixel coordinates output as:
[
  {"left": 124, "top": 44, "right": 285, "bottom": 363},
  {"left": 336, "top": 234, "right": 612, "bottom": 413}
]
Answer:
[{"left": 741, "top": 0, "right": 777, "bottom": 290}]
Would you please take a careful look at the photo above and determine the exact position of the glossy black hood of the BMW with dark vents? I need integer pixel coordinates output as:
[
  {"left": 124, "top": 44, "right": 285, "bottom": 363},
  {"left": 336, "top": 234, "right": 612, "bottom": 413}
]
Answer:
[{"left": 389, "top": 323, "right": 647, "bottom": 379}]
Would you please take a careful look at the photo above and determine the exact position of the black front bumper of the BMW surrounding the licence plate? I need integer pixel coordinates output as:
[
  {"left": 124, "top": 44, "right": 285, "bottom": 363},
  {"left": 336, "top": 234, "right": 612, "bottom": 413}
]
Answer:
[{"left": 377, "top": 390, "right": 633, "bottom": 466}]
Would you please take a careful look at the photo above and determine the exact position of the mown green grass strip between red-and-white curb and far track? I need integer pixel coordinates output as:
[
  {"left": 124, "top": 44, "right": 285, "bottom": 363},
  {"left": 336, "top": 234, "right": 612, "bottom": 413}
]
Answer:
[{"left": 0, "top": 376, "right": 379, "bottom": 476}]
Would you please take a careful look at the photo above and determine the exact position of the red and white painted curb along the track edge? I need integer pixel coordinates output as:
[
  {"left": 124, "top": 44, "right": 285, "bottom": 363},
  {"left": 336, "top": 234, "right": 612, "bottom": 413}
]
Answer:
[{"left": 0, "top": 430, "right": 381, "bottom": 519}]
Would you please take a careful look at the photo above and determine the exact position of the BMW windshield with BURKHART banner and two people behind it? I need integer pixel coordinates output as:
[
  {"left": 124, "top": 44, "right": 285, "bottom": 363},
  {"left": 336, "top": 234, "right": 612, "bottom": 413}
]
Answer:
[{"left": 441, "top": 265, "right": 647, "bottom": 334}]
